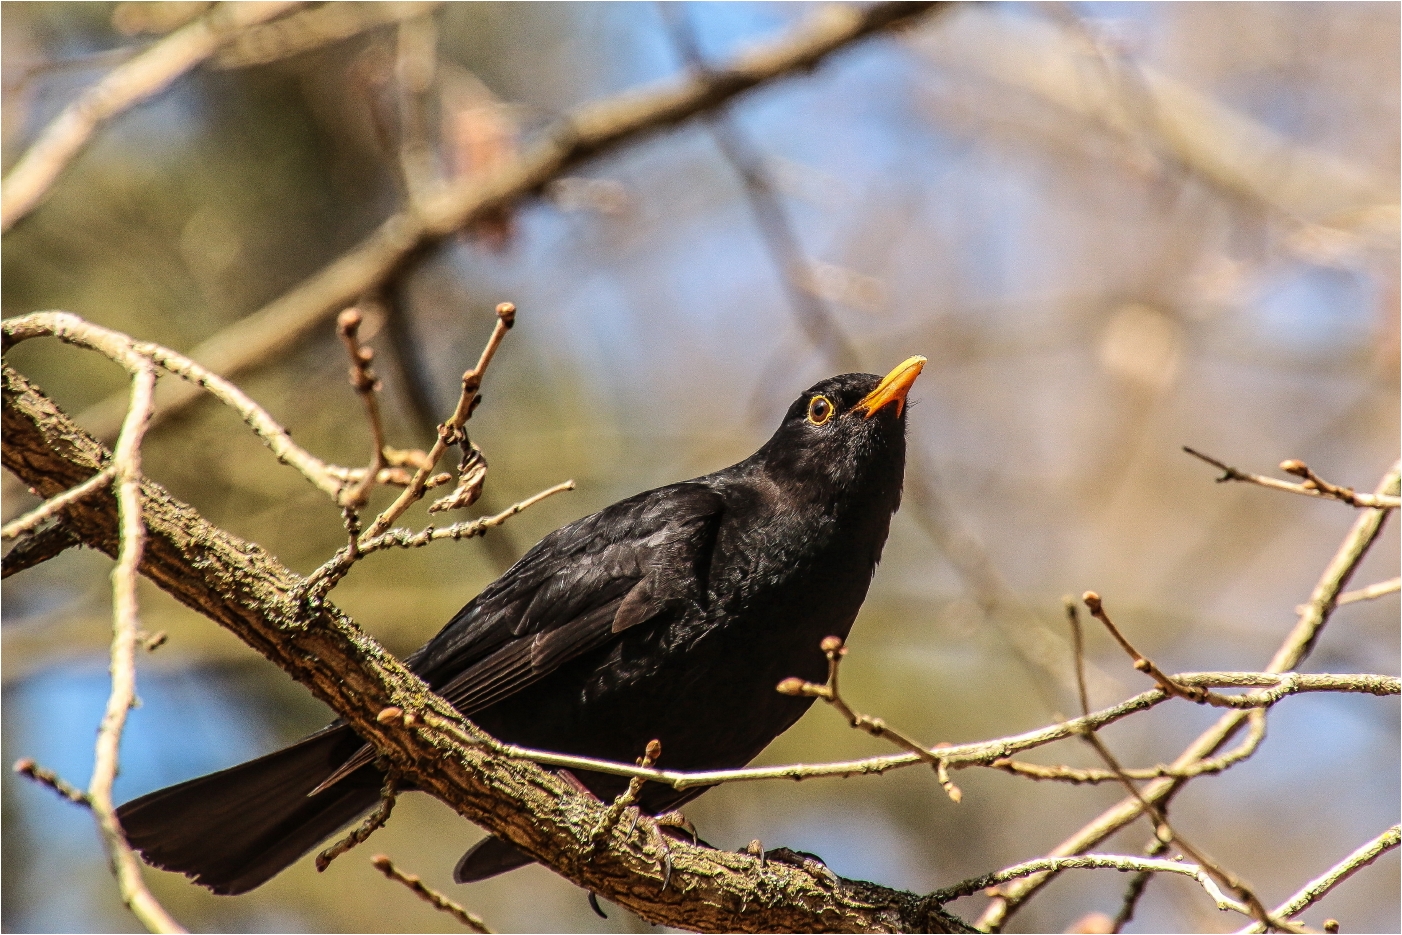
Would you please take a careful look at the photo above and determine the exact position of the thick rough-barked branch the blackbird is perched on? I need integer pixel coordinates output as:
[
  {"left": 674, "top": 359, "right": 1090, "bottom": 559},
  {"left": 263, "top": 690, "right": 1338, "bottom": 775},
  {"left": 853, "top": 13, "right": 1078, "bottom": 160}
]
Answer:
[{"left": 3, "top": 367, "right": 963, "bottom": 932}]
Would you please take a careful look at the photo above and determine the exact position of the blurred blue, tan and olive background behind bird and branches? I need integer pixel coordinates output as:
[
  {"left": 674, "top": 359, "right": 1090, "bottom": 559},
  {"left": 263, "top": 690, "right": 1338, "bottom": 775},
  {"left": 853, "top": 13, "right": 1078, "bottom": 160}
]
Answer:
[{"left": 0, "top": 3, "right": 1399, "bottom": 932}]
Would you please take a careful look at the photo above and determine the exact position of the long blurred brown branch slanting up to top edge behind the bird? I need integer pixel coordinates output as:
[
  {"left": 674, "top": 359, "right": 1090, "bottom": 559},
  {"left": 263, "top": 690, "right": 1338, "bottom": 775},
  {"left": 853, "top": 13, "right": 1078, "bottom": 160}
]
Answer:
[{"left": 65, "top": 3, "right": 945, "bottom": 437}]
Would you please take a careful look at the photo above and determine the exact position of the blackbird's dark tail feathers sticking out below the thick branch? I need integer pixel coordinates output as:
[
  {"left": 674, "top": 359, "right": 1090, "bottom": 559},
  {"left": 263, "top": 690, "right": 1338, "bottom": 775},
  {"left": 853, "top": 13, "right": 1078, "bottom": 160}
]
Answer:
[{"left": 116, "top": 726, "right": 381, "bottom": 896}]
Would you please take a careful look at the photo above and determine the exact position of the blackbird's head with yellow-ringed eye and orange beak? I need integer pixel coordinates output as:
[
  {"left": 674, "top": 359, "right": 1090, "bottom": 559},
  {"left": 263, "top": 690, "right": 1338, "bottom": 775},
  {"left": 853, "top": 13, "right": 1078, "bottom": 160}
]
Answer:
[{"left": 754, "top": 356, "right": 925, "bottom": 510}]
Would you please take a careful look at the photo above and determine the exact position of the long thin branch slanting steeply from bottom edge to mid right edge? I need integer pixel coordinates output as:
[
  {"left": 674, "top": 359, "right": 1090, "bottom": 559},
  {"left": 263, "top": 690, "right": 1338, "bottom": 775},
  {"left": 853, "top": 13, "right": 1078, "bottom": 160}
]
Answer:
[{"left": 979, "top": 464, "right": 1399, "bottom": 931}]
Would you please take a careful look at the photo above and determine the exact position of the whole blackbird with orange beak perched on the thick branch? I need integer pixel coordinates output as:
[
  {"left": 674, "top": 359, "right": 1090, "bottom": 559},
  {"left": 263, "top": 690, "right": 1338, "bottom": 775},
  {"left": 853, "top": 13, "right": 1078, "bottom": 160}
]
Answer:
[{"left": 118, "top": 356, "right": 925, "bottom": 894}]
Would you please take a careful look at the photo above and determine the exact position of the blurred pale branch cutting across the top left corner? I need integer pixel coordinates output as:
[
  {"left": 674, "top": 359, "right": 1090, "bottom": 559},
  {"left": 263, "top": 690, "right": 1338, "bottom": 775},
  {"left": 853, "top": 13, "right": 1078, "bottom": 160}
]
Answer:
[{"left": 0, "top": 1, "right": 297, "bottom": 231}]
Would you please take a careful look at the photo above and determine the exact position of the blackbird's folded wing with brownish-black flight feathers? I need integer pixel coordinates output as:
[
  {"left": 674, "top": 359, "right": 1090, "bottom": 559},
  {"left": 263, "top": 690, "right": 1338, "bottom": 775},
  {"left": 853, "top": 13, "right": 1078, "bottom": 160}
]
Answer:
[{"left": 314, "top": 482, "right": 725, "bottom": 792}]
